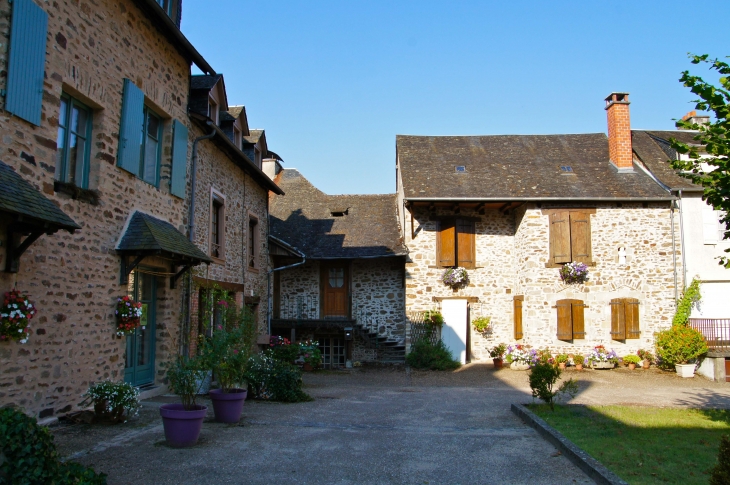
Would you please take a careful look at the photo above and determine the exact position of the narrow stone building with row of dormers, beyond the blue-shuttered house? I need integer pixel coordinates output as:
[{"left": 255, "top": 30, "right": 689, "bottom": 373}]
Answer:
[{"left": 183, "top": 74, "right": 284, "bottom": 352}]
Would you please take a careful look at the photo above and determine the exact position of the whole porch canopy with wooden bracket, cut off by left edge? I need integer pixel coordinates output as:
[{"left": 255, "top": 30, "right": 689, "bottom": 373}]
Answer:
[{"left": 0, "top": 162, "right": 81, "bottom": 273}]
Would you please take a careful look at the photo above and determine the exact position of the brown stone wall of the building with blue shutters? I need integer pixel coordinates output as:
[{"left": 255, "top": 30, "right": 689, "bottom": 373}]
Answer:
[{"left": 0, "top": 0, "right": 189, "bottom": 417}]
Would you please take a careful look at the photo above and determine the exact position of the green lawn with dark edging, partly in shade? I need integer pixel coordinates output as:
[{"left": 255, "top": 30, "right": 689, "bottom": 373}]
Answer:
[{"left": 530, "top": 405, "right": 730, "bottom": 485}]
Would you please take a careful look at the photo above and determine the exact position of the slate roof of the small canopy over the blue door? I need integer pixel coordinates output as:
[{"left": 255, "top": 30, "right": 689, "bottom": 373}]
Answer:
[{"left": 116, "top": 211, "right": 213, "bottom": 263}]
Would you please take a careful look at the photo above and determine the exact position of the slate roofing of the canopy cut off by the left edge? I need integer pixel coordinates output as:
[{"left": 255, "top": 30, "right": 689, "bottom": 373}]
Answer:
[{"left": 0, "top": 162, "right": 81, "bottom": 232}]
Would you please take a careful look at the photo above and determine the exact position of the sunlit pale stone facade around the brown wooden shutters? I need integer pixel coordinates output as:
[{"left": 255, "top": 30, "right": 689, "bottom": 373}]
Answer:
[{"left": 404, "top": 203, "right": 681, "bottom": 361}]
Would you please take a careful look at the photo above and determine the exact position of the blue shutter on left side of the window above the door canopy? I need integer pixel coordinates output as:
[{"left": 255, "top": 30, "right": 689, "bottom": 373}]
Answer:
[{"left": 117, "top": 79, "right": 144, "bottom": 175}]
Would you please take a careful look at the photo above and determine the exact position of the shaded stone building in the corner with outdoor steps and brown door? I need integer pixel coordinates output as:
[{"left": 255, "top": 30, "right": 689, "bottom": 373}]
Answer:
[{"left": 271, "top": 164, "right": 406, "bottom": 367}]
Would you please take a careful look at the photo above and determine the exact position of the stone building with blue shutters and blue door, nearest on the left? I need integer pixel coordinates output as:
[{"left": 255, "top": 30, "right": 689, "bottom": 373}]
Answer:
[{"left": 0, "top": 0, "right": 215, "bottom": 418}]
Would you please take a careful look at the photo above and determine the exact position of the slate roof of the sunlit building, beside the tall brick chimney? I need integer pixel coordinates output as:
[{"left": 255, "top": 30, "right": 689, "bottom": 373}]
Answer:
[{"left": 396, "top": 133, "right": 670, "bottom": 201}]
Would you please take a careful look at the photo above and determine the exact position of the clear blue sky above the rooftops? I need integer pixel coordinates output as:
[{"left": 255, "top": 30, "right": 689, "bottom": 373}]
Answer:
[{"left": 182, "top": 0, "right": 730, "bottom": 194}]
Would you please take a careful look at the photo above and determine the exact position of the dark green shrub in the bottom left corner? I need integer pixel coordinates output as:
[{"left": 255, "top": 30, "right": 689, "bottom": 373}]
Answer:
[{"left": 0, "top": 408, "right": 106, "bottom": 485}]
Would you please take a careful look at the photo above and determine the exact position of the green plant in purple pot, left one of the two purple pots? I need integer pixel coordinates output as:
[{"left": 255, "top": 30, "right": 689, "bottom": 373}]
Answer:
[{"left": 160, "top": 356, "right": 208, "bottom": 448}]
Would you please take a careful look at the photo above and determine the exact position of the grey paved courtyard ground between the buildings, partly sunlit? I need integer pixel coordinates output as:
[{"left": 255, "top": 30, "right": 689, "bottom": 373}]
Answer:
[{"left": 54, "top": 364, "right": 730, "bottom": 485}]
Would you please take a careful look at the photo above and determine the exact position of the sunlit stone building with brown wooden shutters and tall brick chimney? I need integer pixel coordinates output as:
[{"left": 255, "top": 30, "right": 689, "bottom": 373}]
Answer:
[{"left": 396, "top": 93, "right": 682, "bottom": 362}]
